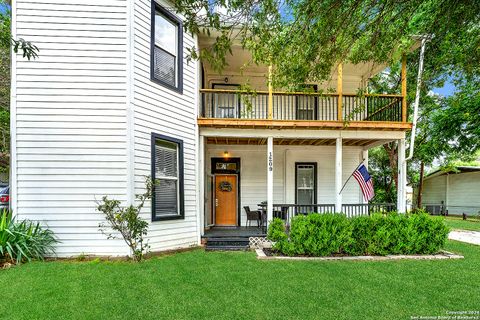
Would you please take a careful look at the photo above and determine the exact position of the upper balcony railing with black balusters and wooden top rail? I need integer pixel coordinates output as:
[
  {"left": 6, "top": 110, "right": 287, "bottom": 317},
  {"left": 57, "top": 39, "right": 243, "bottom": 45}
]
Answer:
[{"left": 200, "top": 89, "right": 402, "bottom": 122}]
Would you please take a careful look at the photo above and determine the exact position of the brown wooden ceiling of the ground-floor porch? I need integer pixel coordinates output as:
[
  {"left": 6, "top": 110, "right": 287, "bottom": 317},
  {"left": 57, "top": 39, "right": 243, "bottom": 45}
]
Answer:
[{"left": 207, "top": 137, "right": 381, "bottom": 147}]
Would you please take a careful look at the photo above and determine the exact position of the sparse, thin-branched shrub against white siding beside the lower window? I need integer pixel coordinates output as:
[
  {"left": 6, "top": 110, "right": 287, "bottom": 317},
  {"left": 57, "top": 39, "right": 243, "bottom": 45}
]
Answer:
[{"left": 97, "top": 178, "right": 153, "bottom": 262}]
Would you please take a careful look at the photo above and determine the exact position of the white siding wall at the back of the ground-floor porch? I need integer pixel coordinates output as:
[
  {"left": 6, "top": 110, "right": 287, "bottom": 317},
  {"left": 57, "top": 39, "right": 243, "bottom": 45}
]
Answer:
[{"left": 205, "top": 145, "right": 363, "bottom": 225}]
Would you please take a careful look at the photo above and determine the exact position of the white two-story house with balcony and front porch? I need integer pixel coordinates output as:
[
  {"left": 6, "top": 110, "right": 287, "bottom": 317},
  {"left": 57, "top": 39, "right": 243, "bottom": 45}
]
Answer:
[{"left": 11, "top": 0, "right": 411, "bottom": 256}]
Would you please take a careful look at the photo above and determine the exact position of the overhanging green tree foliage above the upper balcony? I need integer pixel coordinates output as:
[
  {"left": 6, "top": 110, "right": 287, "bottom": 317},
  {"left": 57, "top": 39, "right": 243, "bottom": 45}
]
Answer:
[{"left": 175, "top": 0, "right": 480, "bottom": 89}]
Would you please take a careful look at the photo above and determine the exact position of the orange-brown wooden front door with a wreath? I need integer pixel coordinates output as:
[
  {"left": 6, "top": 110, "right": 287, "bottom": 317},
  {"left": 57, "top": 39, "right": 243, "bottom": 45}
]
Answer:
[{"left": 215, "top": 174, "right": 237, "bottom": 226}]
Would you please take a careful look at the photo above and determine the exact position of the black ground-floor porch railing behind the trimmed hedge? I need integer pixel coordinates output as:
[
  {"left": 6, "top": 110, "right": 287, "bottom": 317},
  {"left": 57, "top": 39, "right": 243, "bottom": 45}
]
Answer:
[{"left": 273, "top": 203, "right": 397, "bottom": 221}]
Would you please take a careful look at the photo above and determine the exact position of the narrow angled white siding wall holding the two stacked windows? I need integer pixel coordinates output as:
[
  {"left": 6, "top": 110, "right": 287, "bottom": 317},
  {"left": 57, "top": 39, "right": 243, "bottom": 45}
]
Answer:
[{"left": 133, "top": 0, "right": 198, "bottom": 250}]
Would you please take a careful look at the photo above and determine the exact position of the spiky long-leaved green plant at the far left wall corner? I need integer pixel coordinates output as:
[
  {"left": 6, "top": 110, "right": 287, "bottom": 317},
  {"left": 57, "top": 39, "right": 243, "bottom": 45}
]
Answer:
[{"left": 0, "top": 210, "right": 58, "bottom": 263}]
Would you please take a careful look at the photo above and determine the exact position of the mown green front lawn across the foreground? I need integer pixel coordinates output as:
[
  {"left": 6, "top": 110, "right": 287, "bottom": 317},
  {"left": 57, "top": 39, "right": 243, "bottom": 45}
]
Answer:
[{"left": 0, "top": 241, "right": 480, "bottom": 320}]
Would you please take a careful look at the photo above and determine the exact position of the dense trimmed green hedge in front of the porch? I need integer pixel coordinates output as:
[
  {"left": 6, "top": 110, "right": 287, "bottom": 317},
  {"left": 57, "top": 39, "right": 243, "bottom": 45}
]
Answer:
[{"left": 268, "top": 213, "right": 449, "bottom": 256}]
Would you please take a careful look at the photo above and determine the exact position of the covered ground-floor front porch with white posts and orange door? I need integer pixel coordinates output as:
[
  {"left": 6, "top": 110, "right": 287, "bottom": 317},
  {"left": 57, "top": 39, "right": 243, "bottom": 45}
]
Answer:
[{"left": 199, "top": 128, "right": 406, "bottom": 232}]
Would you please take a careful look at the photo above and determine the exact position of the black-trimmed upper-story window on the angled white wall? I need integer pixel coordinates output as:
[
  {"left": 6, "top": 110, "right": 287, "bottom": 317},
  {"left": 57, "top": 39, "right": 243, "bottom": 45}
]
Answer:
[{"left": 150, "top": 0, "right": 183, "bottom": 92}]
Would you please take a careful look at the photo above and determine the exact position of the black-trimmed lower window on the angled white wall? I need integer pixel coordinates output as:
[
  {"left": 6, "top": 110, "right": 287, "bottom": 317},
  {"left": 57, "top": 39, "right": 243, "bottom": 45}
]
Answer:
[{"left": 152, "top": 133, "right": 184, "bottom": 221}]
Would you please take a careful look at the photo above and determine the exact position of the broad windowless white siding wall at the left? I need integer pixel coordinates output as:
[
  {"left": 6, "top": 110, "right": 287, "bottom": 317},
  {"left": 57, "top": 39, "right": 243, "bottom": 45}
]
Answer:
[{"left": 13, "top": 0, "right": 128, "bottom": 256}]
